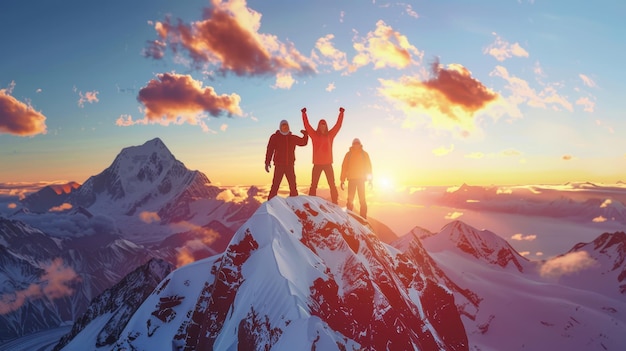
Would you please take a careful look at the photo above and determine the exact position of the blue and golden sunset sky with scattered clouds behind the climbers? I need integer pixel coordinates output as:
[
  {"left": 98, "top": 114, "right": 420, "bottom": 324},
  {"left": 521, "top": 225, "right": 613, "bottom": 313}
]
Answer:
[{"left": 0, "top": 0, "right": 626, "bottom": 190}]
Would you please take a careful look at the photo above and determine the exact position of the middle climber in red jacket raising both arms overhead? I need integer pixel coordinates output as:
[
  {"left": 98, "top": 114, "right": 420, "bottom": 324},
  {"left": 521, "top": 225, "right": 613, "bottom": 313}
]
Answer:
[{"left": 301, "top": 107, "right": 345, "bottom": 204}]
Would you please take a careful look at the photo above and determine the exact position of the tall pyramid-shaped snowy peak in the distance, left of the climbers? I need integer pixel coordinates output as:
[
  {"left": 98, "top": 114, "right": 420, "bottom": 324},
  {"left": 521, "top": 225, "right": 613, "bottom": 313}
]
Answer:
[{"left": 70, "top": 138, "right": 219, "bottom": 222}]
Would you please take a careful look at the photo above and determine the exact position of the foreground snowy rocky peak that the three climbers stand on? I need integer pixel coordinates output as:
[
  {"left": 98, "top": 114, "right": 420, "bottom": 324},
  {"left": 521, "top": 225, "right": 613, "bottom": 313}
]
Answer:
[{"left": 61, "top": 196, "right": 468, "bottom": 350}]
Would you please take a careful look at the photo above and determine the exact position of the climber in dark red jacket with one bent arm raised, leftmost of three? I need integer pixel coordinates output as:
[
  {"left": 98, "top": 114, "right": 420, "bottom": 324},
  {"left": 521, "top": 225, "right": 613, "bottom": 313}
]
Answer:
[{"left": 265, "top": 120, "right": 309, "bottom": 200}]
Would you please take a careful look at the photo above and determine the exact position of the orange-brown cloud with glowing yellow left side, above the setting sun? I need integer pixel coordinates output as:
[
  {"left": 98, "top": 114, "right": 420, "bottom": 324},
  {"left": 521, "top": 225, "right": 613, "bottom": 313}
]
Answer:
[{"left": 378, "top": 61, "right": 499, "bottom": 131}]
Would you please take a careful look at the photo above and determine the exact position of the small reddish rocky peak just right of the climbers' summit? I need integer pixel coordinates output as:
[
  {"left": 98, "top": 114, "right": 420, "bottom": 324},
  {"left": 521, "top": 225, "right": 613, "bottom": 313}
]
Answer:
[{"left": 424, "top": 220, "right": 528, "bottom": 272}]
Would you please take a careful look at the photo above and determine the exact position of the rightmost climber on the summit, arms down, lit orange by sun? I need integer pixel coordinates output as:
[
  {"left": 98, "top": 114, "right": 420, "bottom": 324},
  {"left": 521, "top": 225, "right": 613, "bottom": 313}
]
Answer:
[{"left": 341, "top": 138, "right": 372, "bottom": 218}]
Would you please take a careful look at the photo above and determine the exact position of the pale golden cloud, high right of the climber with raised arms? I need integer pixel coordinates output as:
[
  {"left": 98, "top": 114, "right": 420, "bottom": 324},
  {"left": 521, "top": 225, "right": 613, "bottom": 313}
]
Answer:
[{"left": 350, "top": 20, "right": 423, "bottom": 71}]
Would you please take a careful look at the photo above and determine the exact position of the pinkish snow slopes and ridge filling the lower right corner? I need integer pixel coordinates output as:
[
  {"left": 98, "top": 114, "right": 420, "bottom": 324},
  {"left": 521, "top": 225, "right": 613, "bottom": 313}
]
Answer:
[{"left": 403, "top": 222, "right": 626, "bottom": 351}]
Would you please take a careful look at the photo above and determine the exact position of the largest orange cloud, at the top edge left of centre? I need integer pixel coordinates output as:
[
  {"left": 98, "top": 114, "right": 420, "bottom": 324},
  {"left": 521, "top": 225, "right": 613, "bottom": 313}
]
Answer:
[{"left": 144, "top": 0, "right": 315, "bottom": 76}]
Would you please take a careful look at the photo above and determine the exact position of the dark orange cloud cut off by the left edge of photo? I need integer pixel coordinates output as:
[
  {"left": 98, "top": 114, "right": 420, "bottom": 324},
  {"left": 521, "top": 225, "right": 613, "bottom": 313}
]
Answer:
[{"left": 0, "top": 82, "right": 47, "bottom": 136}]
